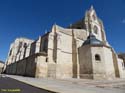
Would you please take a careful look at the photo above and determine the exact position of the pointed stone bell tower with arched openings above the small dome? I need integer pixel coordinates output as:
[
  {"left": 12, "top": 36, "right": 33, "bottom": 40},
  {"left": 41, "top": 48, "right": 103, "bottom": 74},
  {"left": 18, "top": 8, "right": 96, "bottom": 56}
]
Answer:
[{"left": 85, "top": 6, "right": 107, "bottom": 43}]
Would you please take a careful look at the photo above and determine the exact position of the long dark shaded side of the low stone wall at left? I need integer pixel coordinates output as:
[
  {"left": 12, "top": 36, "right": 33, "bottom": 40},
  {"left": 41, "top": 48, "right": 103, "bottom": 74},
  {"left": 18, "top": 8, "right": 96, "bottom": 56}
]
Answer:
[{"left": 6, "top": 53, "right": 46, "bottom": 77}]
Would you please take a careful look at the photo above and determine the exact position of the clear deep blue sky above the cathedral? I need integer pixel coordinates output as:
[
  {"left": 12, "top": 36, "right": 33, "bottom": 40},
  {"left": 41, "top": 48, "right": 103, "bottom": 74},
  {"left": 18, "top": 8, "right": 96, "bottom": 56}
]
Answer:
[{"left": 0, "top": 0, "right": 125, "bottom": 61}]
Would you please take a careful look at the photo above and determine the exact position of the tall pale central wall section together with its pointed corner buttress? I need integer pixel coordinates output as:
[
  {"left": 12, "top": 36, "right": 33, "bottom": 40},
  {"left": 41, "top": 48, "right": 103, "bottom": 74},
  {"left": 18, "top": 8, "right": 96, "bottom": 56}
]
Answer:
[{"left": 47, "top": 26, "right": 72, "bottom": 78}]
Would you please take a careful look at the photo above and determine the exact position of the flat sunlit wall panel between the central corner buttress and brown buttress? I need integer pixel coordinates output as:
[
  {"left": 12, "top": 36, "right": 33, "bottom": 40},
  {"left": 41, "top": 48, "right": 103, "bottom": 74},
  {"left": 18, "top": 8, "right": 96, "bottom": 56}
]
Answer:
[{"left": 56, "top": 32, "right": 73, "bottom": 78}]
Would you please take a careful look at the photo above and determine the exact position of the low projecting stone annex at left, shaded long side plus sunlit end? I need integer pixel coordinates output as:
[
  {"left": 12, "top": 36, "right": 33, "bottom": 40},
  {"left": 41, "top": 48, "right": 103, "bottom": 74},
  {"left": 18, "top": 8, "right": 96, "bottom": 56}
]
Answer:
[{"left": 6, "top": 54, "right": 45, "bottom": 77}]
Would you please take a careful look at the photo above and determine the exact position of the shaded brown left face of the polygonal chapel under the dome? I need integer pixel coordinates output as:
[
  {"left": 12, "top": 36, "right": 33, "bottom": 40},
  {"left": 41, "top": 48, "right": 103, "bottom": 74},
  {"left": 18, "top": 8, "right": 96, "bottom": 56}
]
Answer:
[{"left": 78, "top": 46, "right": 93, "bottom": 79}]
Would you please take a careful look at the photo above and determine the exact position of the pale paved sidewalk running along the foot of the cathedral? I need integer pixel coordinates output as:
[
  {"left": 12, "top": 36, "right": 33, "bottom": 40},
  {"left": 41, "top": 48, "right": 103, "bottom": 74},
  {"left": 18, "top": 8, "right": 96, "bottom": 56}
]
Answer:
[{"left": 6, "top": 75, "right": 125, "bottom": 93}]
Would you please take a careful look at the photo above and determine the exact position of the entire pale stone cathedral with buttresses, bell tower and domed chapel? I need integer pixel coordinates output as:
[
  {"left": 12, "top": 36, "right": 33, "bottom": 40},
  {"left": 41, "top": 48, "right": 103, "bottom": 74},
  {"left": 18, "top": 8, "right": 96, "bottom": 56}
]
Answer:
[{"left": 4, "top": 7, "right": 125, "bottom": 79}]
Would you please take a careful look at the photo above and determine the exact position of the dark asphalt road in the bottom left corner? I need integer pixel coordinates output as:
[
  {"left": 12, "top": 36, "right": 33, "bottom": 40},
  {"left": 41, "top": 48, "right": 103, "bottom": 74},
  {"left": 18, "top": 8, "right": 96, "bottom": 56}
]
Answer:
[{"left": 0, "top": 77, "right": 55, "bottom": 93}]
